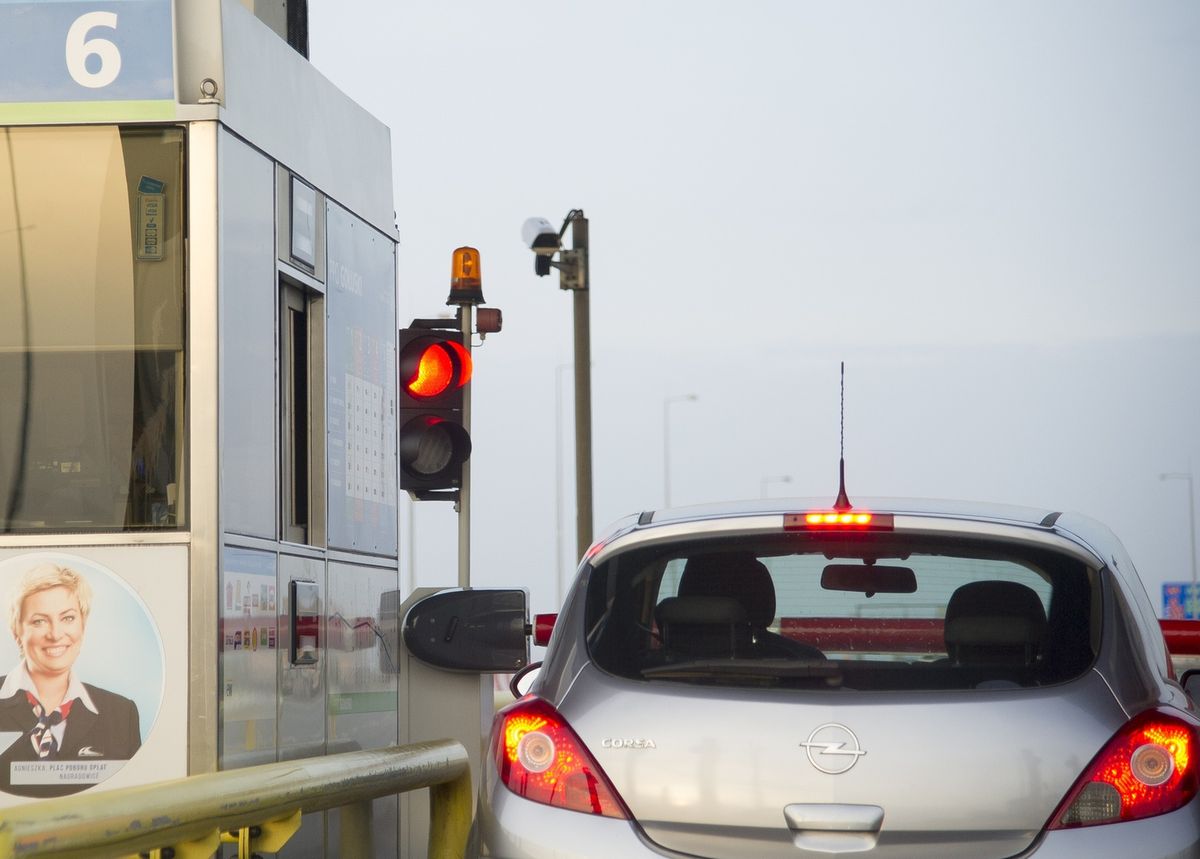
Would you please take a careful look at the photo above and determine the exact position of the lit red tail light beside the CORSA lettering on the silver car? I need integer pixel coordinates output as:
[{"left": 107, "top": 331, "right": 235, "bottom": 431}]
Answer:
[{"left": 492, "top": 697, "right": 629, "bottom": 818}]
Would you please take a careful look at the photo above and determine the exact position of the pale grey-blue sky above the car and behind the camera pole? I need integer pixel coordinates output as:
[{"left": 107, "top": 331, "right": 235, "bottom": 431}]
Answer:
[{"left": 308, "top": 0, "right": 1200, "bottom": 611}]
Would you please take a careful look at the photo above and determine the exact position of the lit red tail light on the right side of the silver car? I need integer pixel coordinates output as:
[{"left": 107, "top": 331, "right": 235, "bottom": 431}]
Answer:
[{"left": 1050, "top": 710, "right": 1200, "bottom": 829}]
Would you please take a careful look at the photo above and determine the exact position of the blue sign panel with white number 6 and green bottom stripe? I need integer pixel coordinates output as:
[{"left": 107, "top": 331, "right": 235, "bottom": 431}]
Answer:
[{"left": 0, "top": 0, "right": 175, "bottom": 121}]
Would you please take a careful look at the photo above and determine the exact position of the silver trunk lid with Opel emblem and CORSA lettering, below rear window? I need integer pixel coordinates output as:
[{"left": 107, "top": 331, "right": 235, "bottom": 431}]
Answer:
[{"left": 559, "top": 666, "right": 1126, "bottom": 859}]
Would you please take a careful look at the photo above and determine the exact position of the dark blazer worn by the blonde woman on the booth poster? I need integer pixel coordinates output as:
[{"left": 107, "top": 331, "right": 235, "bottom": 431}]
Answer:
[{"left": 0, "top": 677, "right": 142, "bottom": 797}]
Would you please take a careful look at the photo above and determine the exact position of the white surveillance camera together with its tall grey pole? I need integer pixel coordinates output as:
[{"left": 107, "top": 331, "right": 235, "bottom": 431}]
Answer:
[{"left": 521, "top": 209, "right": 592, "bottom": 558}]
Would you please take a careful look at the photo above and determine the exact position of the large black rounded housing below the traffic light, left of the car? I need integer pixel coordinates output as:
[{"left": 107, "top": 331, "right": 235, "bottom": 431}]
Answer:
[{"left": 403, "top": 589, "right": 529, "bottom": 674}]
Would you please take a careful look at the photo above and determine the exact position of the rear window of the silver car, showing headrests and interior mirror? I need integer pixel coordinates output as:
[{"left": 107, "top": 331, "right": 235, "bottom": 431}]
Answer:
[{"left": 586, "top": 534, "right": 1099, "bottom": 691}]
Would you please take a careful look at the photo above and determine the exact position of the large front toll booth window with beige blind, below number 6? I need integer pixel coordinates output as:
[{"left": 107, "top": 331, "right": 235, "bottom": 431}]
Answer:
[{"left": 0, "top": 126, "right": 186, "bottom": 533}]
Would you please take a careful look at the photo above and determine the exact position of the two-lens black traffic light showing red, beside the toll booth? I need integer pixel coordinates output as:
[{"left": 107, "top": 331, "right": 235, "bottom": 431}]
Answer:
[{"left": 398, "top": 319, "right": 472, "bottom": 500}]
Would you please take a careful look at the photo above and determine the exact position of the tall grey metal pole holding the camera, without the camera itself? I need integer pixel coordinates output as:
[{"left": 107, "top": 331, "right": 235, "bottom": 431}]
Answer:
[{"left": 571, "top": 218, "right": 592, "bottom": 558}]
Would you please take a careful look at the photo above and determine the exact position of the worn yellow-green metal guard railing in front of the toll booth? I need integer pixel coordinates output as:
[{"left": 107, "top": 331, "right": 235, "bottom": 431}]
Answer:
[{"left": 0, "top": 740, "right": 472, "bottom": 859}]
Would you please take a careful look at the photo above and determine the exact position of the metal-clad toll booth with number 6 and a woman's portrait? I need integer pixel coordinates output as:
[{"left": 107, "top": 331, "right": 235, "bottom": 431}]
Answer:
[{"left": 0, "top": 0, "right": 491, "bottom": 857}]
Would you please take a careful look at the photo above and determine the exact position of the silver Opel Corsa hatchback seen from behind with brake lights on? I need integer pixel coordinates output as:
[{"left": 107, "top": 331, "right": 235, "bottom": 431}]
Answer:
[{"left": 476, "top": 500, "right": 1200, "bottom": 859}]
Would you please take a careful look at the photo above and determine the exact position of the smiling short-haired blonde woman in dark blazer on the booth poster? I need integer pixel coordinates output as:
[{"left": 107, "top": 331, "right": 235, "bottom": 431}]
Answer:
[{"left": 0, "top": 564, "right": 142, "bottom": 797}]
